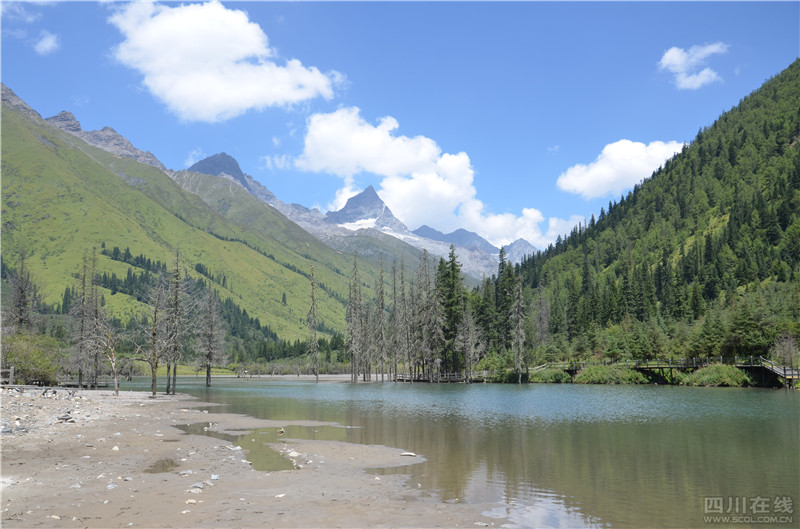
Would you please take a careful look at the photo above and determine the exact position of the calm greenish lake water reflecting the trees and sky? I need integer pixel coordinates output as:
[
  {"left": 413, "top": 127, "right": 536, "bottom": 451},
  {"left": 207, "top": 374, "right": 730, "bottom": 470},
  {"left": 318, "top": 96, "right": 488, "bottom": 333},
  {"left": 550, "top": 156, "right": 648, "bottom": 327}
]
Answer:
[{"left": 122, "top": 377, "right": 800, "bottom": 527}]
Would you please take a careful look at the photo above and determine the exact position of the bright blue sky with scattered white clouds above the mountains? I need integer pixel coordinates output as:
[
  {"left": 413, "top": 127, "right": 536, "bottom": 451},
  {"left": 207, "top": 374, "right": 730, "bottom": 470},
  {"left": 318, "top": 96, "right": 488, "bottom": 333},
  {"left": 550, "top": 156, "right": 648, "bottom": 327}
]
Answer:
[{"left": 0, "top": 1, "right": 800, "bottom": 248}]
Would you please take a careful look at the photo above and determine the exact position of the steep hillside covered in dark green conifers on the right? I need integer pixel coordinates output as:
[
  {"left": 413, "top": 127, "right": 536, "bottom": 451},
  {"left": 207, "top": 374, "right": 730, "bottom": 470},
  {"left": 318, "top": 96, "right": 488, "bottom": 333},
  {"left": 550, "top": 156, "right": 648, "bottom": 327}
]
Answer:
[{"left": 512, "top": 61, "right": 800, "bottom": 360}]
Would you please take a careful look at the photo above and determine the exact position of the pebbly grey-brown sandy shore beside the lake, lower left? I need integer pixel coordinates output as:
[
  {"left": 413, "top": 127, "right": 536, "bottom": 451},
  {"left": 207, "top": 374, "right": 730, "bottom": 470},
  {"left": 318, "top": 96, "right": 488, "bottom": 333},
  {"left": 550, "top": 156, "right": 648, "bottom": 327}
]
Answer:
[{"left": 0, "top": 389, "right": 504, "bottom": 528}]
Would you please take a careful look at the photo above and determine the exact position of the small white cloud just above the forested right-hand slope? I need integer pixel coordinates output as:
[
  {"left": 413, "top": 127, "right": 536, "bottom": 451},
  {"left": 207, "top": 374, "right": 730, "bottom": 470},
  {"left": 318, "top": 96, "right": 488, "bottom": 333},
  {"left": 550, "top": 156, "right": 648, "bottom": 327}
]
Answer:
[{"left": 556, "top": 140, "right": 683, "bottom": 200}]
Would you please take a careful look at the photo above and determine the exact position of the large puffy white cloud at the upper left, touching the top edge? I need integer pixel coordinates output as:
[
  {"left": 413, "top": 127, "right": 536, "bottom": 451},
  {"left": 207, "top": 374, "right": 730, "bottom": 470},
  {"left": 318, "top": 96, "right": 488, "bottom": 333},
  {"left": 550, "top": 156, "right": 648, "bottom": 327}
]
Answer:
[{"left": 109, "top": 0, "right": 343, "bottom": 122}]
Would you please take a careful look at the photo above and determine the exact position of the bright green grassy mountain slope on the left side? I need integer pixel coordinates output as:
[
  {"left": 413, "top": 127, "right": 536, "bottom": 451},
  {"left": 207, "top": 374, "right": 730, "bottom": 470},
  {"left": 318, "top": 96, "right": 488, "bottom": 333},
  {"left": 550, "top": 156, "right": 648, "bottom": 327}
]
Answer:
[{"left": 0, "top": 98, "right": 377, "bottom": 340}]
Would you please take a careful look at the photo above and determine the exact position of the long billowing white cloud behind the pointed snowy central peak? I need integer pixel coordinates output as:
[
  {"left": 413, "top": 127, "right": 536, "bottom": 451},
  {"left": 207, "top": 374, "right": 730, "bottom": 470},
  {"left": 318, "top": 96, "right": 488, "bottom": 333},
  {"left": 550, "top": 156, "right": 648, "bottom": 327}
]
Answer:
[{"left": 294, "top": 107, "right": 577, "bottom": 247}]
